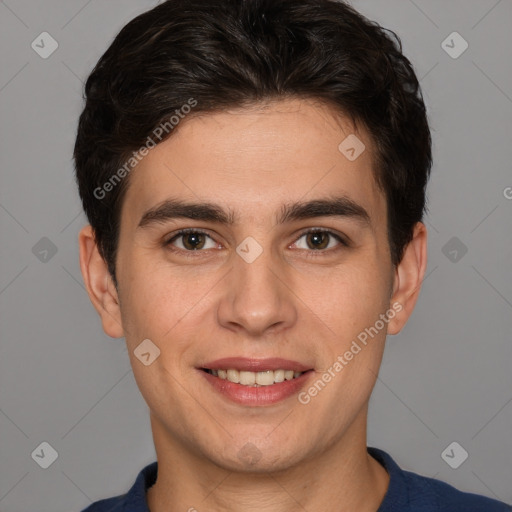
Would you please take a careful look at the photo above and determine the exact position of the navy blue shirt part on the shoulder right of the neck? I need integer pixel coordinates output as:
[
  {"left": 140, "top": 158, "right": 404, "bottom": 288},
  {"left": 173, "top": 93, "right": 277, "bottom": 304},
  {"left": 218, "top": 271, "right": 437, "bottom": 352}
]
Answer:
[{"left": 368, "top": 448, "right": 512, "bottom": 512}]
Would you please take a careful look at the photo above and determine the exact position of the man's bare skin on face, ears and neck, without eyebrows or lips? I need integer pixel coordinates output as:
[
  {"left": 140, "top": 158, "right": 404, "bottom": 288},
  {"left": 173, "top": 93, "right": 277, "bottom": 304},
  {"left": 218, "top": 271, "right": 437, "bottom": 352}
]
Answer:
[{"left": 79, "top": 99, "right": 427, "bottom": 512}]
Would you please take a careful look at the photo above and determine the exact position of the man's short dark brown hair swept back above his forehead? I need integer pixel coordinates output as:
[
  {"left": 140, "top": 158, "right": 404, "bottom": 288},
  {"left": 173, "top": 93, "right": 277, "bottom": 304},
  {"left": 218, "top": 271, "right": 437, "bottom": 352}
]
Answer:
[{"left": 74, "top": 0, "right": 432, "bottom": 283}]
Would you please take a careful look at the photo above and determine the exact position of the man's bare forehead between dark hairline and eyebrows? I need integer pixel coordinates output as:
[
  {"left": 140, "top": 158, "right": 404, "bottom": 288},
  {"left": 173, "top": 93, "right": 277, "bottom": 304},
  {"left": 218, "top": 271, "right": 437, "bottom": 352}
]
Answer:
[{"left": 119, "top": 99, "right": 385, "bottom": 226}]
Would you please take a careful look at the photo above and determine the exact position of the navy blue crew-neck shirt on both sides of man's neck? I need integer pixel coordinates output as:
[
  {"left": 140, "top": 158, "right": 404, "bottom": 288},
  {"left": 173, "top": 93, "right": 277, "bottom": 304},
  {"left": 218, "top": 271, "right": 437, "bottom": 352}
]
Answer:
[{"left": 82, "top": 448, "right": 512, "bottom": 512}]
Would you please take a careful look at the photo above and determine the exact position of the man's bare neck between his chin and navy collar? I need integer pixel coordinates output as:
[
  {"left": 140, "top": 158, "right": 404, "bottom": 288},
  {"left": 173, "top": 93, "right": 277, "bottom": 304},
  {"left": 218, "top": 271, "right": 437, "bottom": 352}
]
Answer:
[{"left": 147, "top": 412, "right": 389, "bottom": 512}]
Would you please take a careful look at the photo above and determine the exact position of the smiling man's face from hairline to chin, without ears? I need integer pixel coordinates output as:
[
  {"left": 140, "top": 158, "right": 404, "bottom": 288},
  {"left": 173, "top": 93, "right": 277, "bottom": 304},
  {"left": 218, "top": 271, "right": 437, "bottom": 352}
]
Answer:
[{"left": 110, "top": 100, "right": 397, "bottom": 470}]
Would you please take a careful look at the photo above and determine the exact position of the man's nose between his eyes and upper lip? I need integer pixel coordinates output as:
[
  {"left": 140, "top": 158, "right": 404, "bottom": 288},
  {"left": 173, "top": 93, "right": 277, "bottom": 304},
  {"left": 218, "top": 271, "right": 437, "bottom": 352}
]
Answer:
[{"left": 217, "top": 247, "right": 297, "bottom": 337}]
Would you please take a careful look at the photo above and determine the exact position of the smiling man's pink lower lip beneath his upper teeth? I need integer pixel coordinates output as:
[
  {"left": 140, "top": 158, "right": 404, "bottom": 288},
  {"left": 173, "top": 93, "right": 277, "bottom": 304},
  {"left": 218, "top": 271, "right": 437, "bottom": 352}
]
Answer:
[{"left": 198, "top": 370, "right": 313, "bottom": 406}]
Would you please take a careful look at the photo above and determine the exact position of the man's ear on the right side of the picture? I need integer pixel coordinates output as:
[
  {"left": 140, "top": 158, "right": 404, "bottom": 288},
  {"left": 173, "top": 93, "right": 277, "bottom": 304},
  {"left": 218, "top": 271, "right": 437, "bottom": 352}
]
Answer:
[{"left": 388, "top": 222, "right": 427, "bottom": 334}]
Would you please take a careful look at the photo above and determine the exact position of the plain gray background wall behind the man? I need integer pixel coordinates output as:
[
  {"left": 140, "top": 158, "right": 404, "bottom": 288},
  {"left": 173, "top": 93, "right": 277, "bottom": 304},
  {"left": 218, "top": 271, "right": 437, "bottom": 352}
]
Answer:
[{"left": 0, "top": 0, "right": 512, "bottom": 512}]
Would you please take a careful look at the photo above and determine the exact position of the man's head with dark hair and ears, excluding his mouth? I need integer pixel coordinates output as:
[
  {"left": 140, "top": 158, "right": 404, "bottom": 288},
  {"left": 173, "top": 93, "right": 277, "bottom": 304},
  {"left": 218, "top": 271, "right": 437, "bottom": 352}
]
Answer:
[{"left": 74, "top": 0, "right": 432, "bottom": 468}]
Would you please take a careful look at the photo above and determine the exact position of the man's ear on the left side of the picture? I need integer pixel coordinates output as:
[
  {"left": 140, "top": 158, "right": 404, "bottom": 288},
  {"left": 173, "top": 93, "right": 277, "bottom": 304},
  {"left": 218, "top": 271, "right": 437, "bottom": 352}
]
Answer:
[{"left": 78, "top": 226, "right": 124, "bottom": 338}]
